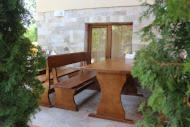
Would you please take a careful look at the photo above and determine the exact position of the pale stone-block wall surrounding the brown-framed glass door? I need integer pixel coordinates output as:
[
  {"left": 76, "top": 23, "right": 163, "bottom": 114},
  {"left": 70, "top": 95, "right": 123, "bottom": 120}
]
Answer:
[{"left": 38, "top": 6, "right": 153, "bottom": 54}]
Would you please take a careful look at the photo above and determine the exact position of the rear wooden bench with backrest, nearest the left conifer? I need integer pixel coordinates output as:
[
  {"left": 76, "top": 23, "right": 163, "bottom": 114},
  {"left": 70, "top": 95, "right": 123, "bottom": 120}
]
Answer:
[{"left": 38, "top": 52, "right": 90, "bottom": 106}]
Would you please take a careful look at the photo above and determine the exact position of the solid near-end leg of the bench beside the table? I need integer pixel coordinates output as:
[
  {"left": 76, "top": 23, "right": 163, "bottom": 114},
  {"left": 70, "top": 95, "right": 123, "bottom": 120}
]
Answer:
[{"left": 55, "top": 88, "right": 78, "bottom": 111}]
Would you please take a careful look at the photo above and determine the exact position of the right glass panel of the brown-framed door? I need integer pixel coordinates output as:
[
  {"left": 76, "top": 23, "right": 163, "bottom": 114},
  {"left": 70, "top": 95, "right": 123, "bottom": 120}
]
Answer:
[{"left": 111, "top": 25, "right": 133, "bottom": 58}]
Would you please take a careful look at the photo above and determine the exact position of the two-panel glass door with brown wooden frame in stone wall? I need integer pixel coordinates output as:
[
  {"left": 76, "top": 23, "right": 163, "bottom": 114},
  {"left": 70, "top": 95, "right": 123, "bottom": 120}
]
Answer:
[{"left": 87, "top": 23, "right": 133, "bottom": 63}]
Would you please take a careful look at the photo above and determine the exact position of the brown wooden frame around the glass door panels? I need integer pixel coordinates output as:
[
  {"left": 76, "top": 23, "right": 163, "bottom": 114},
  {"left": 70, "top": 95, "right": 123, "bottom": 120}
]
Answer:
[{"left": 85, "top": 22, "right": 133, "bottom": 59}]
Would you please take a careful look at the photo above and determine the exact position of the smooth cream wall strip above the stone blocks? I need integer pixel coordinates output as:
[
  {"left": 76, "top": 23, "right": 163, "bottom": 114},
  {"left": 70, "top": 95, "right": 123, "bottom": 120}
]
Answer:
[{"left": 37, "top": 0, "right": 152, "bottom": 12}]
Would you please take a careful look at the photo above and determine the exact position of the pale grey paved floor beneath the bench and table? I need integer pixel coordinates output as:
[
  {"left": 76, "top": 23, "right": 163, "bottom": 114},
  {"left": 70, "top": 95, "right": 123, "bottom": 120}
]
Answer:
[{"left": 32, "top": 90, "right": 143, "bottom": 127}]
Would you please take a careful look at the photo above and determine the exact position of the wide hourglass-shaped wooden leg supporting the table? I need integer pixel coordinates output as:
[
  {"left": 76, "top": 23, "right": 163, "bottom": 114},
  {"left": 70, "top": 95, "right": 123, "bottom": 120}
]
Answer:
[{"left": 89, "top": 72, "right": 134, "bottom": 124}]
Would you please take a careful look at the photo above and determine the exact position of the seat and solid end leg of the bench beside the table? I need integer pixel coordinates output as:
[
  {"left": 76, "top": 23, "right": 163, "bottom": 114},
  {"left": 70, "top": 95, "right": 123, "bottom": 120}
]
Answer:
[{"left": 54, "top": 71, "right": 96, "bottom": 111}]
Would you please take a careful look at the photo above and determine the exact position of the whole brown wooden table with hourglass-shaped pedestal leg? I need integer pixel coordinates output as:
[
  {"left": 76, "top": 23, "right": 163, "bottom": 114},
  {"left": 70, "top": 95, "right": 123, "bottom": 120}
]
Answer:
[{"left": 84, "top": 59, "right": 134, "bottom": 124}]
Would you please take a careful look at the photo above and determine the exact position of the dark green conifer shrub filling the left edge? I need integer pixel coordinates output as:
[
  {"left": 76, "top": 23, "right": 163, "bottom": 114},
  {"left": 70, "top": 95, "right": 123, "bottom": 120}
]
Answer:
[{"left": 0, "top": 0, "right": 43, "bottom": 127}]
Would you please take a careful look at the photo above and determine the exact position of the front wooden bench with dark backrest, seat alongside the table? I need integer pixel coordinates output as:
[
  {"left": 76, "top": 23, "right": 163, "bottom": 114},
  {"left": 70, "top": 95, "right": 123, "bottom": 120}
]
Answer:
[{"left": 47, "top": 52, "right": 96, "bottom": 111}]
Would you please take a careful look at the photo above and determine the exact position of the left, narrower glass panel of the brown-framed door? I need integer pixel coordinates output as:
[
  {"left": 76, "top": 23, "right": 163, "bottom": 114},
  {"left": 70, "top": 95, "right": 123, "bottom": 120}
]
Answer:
[{"left": 91, "top": 27, "right": 107, "bottom": 63}]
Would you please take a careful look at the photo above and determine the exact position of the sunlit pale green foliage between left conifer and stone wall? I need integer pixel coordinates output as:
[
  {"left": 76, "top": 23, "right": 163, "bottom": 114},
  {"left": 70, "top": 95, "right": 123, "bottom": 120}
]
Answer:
[{"left": 24, "top": 24, "right": 37, "bottom": 42}]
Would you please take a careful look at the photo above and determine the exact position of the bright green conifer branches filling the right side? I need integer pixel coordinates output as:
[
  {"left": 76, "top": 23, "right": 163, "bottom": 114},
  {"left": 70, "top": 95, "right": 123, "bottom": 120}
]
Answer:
[{"left": 132, "top": 0, "right": 190, "bottom": 127}]
